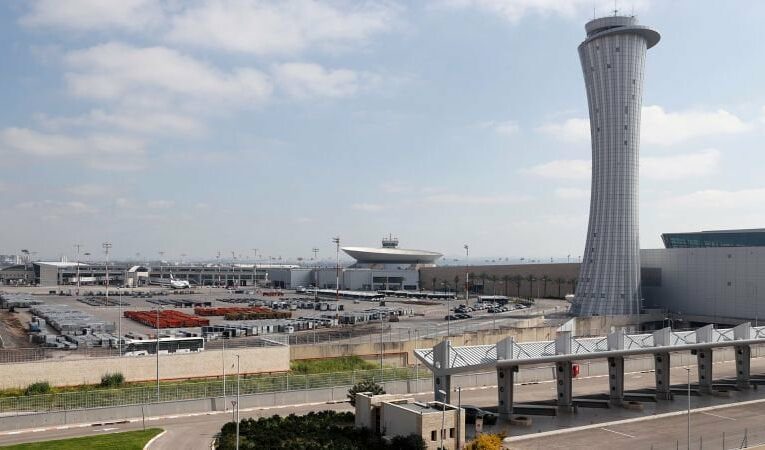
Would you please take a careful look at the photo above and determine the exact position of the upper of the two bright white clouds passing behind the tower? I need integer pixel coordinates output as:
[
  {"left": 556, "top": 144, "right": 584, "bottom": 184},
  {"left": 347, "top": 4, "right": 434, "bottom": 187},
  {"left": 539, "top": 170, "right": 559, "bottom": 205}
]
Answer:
[{"left": 537, "top": 105, "right": 752, "bottom": 145}]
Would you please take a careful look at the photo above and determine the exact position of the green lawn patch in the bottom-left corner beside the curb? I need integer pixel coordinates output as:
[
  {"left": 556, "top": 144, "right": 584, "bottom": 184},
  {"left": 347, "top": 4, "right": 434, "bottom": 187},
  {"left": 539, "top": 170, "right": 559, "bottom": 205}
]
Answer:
[{"left": 0, "top": 428, "right": 162, "bottom": 450}]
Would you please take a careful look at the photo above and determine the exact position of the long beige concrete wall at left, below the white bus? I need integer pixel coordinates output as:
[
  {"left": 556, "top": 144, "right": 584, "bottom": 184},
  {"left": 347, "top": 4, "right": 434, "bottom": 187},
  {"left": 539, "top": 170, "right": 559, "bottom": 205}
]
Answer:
[{"left": 0, "top": 347, "right": 290, "bottom": 389}]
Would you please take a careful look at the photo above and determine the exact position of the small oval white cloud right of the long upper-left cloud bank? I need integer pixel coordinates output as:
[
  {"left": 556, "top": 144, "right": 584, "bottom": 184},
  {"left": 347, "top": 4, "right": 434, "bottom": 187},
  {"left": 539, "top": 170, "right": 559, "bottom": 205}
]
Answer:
[{"left": 272, "top": 63, "right": 376, "bottom": 98}]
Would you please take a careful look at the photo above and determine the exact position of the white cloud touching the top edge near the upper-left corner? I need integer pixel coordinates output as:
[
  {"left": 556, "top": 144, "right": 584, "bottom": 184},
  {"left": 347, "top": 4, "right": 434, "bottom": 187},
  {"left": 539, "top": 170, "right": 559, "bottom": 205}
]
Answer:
[{"left": 21, "top": 0, "right": 164, "bottom": 31}]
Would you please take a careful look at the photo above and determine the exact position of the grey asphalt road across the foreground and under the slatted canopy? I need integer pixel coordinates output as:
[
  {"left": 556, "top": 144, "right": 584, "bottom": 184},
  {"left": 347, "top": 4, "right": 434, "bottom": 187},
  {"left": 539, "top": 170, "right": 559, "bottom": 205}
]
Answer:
[{"left": 0, "top": 358, "right": 765, "bottom": 450}]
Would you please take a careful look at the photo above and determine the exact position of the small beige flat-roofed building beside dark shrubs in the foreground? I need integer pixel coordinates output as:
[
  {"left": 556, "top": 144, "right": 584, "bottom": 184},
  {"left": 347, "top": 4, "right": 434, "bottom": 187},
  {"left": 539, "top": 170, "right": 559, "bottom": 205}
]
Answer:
[{"left": 356, "top": 392, "right": 465, "bottom": 450}]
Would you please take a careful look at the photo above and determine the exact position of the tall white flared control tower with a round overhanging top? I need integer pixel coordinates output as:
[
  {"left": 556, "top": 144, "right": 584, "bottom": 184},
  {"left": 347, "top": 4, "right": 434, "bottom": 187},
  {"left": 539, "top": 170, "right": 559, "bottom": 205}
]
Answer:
[{"left": 572, "top": 16, "right": 659, "bottom": 316}]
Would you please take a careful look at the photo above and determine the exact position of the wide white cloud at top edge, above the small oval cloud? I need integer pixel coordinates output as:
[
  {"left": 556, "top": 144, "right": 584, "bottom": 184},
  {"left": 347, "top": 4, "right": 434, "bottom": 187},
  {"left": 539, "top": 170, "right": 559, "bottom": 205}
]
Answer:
[{"left": 167, "top": 0, "right": 398, "bottom": 55}]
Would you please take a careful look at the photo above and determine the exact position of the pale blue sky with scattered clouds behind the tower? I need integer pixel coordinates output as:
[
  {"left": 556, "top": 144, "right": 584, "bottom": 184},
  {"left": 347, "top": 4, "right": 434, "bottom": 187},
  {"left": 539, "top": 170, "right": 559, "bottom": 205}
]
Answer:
[{"left": 0, "top": 0, "right": 765, "bottom": 261}]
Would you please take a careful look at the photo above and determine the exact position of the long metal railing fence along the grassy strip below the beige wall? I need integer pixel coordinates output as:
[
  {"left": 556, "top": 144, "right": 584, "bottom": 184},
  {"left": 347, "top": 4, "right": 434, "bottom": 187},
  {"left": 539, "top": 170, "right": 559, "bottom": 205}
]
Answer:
[{"left": 0, "top": 367, "right": 431, "bottom": 416}]
